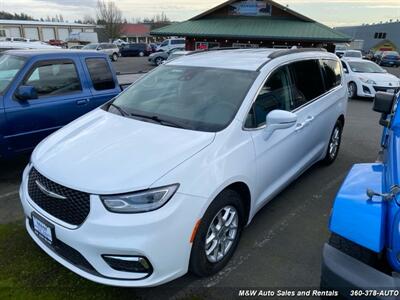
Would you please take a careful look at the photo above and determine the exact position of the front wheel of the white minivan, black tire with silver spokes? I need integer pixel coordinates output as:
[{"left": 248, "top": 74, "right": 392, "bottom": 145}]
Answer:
[{"left": 189, "top": 190, "right": 244, "bottom": 277}]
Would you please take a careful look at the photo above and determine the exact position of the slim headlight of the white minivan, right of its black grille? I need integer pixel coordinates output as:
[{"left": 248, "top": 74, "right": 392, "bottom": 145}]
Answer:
[{"left": 100, "top": 184, "right": 179, "bottom": 213}]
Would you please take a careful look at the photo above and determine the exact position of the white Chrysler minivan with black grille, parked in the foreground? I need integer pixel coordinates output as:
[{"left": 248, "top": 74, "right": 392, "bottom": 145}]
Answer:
[{"left": 20, "top": 49, "right": 347, "bottom": 287}]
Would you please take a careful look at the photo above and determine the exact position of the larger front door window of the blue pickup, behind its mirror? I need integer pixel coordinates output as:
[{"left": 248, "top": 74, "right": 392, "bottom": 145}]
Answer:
[{"left": 23, "top": 61, "right": 82, "bottom": 98}]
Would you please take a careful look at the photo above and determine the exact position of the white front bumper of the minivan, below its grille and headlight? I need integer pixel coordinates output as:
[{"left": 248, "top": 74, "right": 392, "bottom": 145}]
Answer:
[{"left": 20, "top": 165, "right": 206, "bottom": 287}]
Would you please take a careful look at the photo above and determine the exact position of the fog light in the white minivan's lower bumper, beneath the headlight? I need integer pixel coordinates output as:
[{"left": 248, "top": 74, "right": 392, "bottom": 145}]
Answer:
[{"left": 102, "top": 255, "right": 153, "bottom": 275}]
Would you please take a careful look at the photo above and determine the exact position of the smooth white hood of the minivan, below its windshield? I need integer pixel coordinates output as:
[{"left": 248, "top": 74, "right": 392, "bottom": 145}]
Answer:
[{"left": 32, "top": 109, "right": 215, "bottom": 194}]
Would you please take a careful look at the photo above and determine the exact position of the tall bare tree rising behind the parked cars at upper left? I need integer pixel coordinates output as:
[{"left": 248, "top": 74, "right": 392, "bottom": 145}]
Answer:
[{"left": 97, "top": 0, "right": 122, "bottom": 40}]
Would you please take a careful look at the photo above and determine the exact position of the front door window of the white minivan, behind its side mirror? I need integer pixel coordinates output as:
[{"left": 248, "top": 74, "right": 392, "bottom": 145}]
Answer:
[{"left": 245, "top": 66, "right": 293, "bottom": 129}]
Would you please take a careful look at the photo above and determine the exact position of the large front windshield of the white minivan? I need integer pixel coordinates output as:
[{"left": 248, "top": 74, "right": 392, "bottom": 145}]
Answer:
[{"left": 105, "top": 65, "right": 258, "bottom": 132}]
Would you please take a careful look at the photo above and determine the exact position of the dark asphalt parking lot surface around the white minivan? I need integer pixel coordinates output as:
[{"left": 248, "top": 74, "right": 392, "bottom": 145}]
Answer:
[{"left": 0, "top": 58, "right": 400, "bottom": 298}]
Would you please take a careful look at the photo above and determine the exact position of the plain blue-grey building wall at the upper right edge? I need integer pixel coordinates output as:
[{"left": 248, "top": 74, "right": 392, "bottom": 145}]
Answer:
[{"left": 336, "top": 22, "right": 400, "bottom": 51}]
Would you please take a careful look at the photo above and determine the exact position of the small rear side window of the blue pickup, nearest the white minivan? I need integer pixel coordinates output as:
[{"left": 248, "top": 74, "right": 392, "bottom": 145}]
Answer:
[{"left": 86, "top": 58, "right": 115, "bottom": 91}]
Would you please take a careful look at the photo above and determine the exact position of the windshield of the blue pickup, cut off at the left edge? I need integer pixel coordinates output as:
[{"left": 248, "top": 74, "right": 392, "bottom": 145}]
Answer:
[{"left": 0, "top": 54, "right": 26, "bottom": 94}]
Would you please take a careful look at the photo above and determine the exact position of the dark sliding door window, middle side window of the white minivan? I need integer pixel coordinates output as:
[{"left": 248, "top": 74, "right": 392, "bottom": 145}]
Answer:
[{"left": 291, "top": 59, "right": 325, "bottom": 108}]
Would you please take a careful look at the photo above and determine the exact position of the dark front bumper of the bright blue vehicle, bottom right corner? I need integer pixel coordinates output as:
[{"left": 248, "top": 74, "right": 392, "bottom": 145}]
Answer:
[{"left": 321, "top": 244, "right": 400, "bottom": 299}]
